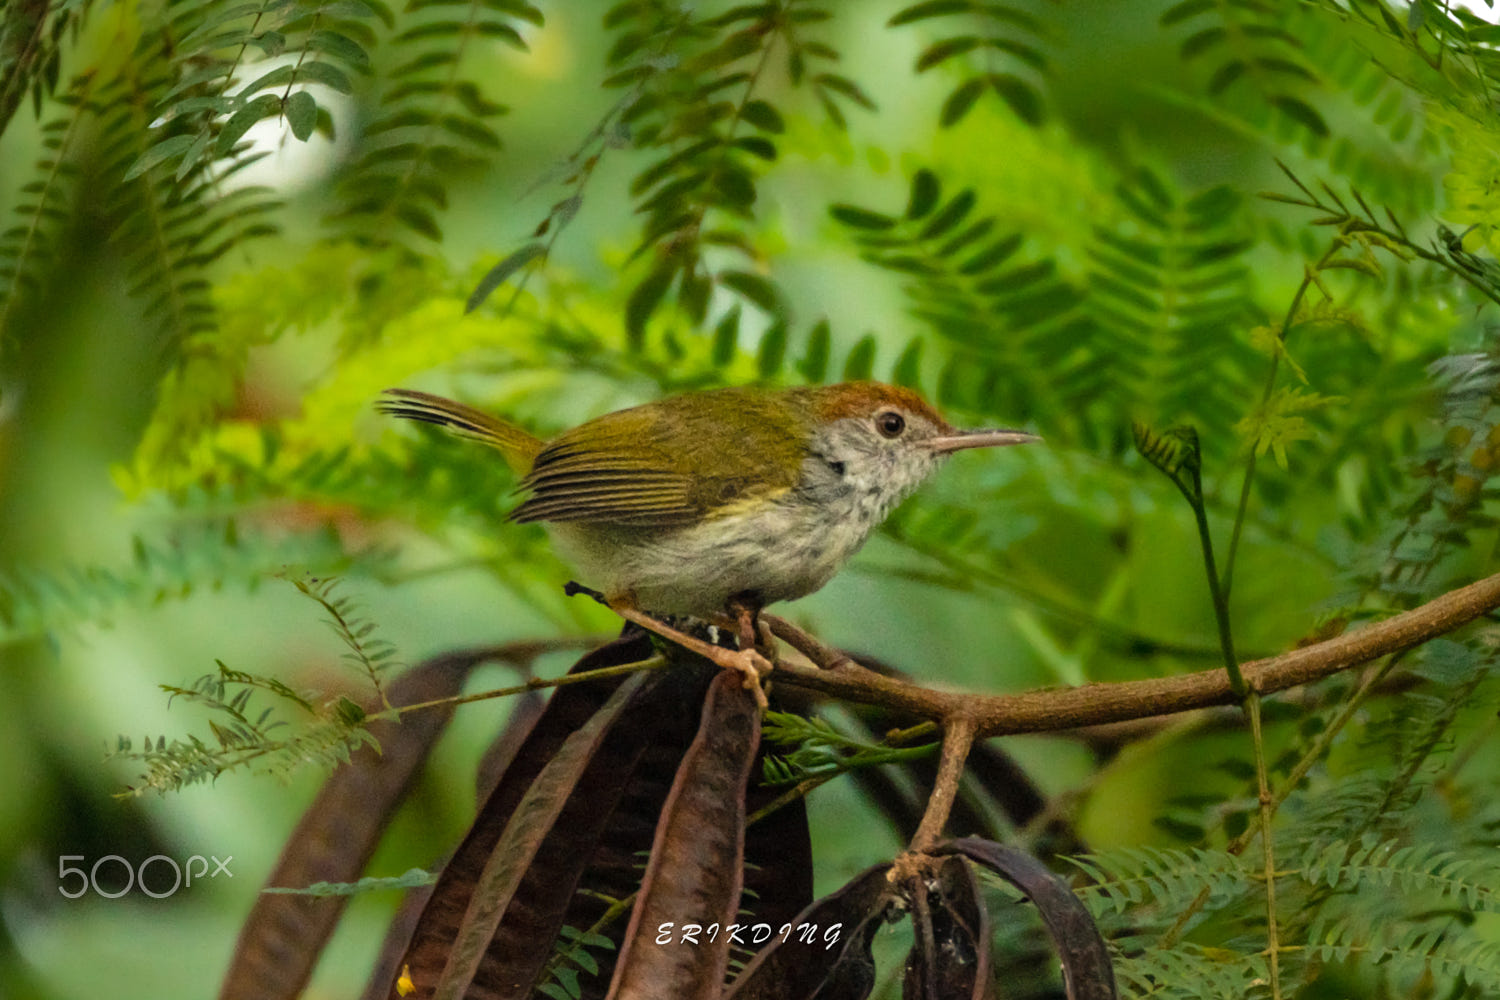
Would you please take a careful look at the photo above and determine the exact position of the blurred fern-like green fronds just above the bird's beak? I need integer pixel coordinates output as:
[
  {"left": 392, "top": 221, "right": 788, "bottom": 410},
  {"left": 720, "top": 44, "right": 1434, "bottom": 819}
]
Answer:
[{"left": 831, "top": 168, "right": 1278, "bottom": 458}]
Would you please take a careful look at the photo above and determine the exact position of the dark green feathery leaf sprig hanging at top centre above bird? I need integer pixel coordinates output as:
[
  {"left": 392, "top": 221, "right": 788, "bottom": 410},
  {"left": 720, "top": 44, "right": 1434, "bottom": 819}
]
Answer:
[{"left": 605, "top": 0, "right": 873, "bottom": 342}]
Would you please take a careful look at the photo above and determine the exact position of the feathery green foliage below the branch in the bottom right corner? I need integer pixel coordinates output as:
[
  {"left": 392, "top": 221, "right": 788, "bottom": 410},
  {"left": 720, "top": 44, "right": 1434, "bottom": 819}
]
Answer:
[{"left": 1074, "top": 629, "right": 1500, "bottom": 997}]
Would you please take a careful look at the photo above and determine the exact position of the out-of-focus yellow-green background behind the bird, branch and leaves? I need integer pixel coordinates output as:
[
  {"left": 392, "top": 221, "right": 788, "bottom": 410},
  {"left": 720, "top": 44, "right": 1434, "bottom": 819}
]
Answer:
[{"left": 0, "top": 0, "right": 1500, "bottom": 1000}]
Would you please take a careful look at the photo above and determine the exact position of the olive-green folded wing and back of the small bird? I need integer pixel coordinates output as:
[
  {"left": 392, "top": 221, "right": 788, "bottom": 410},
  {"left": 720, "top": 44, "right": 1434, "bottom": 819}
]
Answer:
[{"left": 510, "top": 388, "right": 804, "bottom": 528}]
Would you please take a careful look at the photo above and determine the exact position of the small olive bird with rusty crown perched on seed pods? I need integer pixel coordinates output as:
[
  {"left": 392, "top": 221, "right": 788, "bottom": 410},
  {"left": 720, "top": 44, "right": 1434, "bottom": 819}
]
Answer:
[{"left": 377, "top": 381, "right": 1040, "bottom": 701}]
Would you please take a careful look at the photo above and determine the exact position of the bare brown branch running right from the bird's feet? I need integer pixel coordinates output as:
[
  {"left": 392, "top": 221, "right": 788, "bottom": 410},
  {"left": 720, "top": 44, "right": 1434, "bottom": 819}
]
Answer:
[{"left": 765, "top": 573, "right": 1500, "bottom": 738}]
